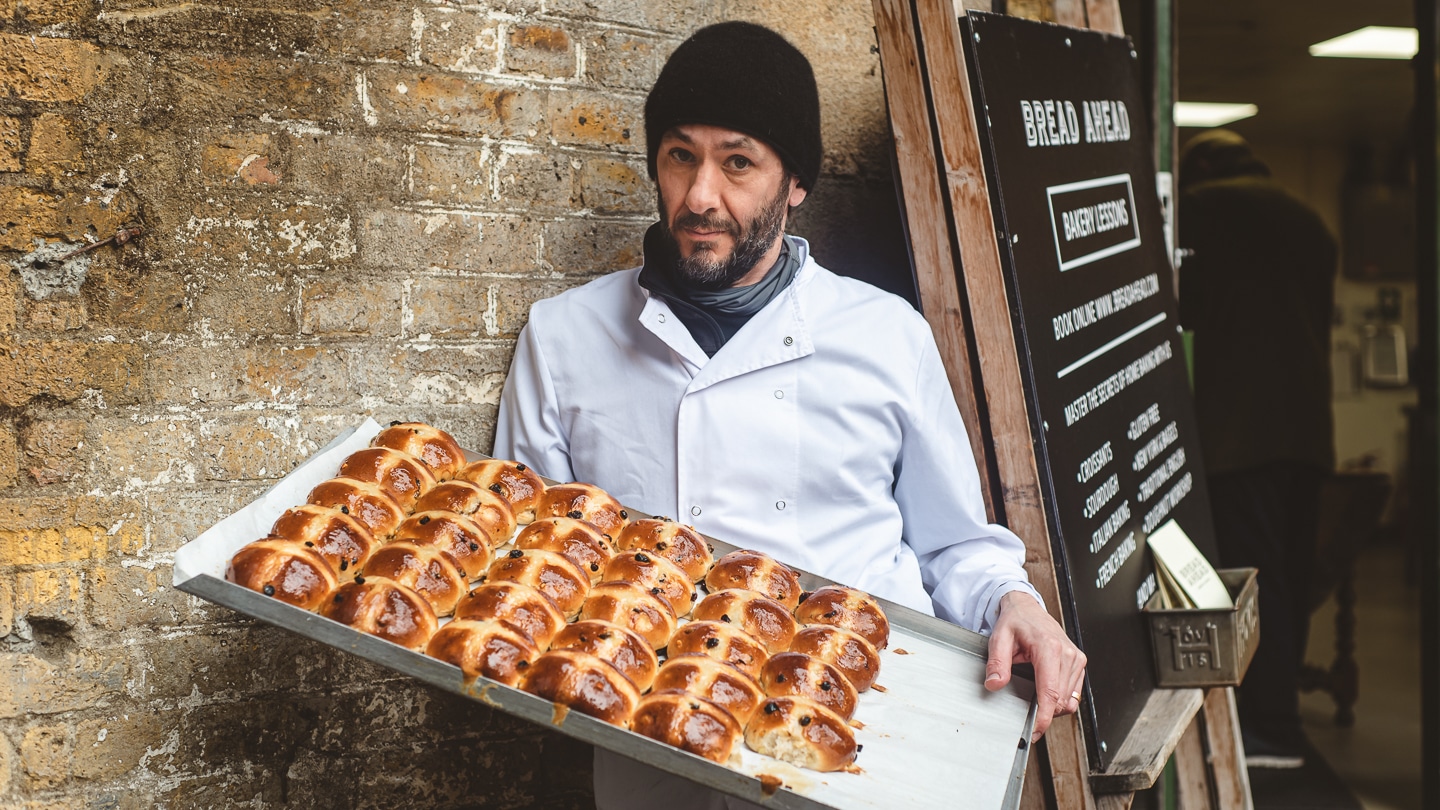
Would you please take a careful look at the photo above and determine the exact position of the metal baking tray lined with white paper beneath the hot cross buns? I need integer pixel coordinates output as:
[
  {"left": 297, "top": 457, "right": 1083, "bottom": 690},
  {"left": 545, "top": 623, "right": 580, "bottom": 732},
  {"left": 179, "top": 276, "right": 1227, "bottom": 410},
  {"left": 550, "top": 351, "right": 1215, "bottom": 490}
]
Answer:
[{"left": 174, "top": 419, "right": 1035, "bottom": 810}]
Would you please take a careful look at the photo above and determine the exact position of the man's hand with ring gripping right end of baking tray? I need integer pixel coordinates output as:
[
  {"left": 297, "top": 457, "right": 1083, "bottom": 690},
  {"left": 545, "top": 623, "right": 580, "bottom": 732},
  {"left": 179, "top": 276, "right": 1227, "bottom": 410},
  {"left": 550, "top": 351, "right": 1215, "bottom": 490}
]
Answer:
[{"left": 985, "top": 591, "right": 1086, "bottom": 742}]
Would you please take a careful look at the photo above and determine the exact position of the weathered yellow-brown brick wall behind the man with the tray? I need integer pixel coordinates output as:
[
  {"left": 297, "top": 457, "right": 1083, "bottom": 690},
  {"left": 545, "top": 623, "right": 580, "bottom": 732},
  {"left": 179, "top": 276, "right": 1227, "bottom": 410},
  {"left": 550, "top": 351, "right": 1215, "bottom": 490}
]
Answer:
[{"left": 0, "top": 0, "right": 904, "bottom": 809}]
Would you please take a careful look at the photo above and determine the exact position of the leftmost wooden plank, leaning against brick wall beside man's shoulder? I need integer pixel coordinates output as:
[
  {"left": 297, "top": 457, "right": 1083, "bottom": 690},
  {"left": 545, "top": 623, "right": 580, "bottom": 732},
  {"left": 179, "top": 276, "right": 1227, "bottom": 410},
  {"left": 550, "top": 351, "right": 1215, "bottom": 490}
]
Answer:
[{"left": 874, "top": 0, "right": 996, "bottom": 520}]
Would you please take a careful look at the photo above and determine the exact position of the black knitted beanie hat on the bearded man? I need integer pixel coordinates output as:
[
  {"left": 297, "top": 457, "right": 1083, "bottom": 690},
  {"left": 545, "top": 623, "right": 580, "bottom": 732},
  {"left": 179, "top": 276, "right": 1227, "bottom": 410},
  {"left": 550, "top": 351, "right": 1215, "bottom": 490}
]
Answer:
[{"left": 645, "top": 22, "right": 821, "bottom": 190}]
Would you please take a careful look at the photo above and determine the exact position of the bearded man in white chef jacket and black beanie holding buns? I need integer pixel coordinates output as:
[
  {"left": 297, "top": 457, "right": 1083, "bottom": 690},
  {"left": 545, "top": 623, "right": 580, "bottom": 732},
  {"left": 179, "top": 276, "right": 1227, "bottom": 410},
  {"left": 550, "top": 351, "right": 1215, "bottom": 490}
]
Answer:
[{"left": 495, "top": 23, "right": 1084, "bottom": 807}]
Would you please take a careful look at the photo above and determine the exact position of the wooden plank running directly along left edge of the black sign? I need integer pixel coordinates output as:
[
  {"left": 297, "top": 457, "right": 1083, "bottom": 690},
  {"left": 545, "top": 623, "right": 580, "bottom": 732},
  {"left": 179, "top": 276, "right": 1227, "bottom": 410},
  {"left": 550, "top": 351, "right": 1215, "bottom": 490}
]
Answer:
[{"left": 914, "top": 0, "right": 1094, "bottom": 810}]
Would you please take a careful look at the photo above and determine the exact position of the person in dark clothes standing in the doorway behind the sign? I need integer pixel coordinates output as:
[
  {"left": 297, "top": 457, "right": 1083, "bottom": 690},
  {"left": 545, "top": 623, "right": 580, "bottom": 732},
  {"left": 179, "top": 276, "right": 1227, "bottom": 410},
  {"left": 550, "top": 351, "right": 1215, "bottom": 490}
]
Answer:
[{"left": 1179, "top": 130, "right": 1335, "bottom": 768}]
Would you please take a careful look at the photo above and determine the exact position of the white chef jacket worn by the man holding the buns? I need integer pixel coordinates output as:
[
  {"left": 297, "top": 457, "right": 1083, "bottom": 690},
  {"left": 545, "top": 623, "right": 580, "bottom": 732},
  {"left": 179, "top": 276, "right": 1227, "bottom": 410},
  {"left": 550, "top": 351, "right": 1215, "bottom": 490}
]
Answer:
[{"left": 494, "top": 239, "right": 1040, "bottom": 807}]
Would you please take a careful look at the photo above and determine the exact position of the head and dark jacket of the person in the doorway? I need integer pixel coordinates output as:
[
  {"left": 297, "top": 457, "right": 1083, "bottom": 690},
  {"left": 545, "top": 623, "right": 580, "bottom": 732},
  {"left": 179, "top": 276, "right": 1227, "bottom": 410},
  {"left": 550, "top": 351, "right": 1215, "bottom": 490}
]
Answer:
[{"left": 1179, "top": 138, "right": 1336, "bottom": 474}]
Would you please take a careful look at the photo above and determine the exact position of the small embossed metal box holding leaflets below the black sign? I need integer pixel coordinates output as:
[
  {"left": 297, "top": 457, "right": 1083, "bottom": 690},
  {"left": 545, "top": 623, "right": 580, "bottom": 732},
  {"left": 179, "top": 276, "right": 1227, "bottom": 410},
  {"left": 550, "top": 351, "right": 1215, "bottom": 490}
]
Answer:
[{"left": 1143, "top": 568, "right": 1260, "bottom": 689}]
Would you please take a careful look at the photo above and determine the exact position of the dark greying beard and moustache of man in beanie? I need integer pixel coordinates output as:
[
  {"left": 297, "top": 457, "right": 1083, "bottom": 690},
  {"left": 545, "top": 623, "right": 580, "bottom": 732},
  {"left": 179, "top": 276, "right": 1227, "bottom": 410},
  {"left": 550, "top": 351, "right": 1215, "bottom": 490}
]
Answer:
[{"left": 660, "top": 177, "right": 791, "bottom": 293}]
